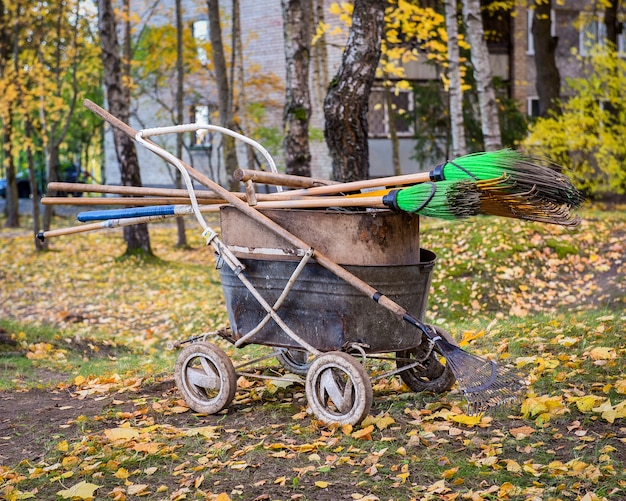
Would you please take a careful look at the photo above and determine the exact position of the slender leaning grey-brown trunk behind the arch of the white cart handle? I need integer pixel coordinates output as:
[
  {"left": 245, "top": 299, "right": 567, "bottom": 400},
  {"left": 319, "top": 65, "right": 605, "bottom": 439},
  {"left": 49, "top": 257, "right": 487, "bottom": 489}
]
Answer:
[{"left": 207, "top": 0, "right": 239, "bottom": 191}]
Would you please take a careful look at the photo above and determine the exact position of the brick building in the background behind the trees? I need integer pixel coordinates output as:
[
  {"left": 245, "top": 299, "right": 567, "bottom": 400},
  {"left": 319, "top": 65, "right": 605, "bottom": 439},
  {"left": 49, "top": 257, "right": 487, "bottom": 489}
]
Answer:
[{"left": 105, "top": 0, "right": 626, "bottom": 185}]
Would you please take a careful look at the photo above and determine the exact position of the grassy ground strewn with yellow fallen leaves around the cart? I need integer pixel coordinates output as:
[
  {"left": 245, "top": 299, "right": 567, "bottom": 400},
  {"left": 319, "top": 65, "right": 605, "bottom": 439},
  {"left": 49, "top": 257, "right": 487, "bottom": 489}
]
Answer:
[{"left": 0, "top": 206, "right": 626, "bottom": 501}]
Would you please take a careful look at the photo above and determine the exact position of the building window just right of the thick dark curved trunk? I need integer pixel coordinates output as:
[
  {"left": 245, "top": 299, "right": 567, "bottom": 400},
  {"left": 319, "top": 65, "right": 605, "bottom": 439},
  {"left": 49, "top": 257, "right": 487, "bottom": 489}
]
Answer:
[{"left": 367, "top": 87, "right": 414, "bottom": 138}]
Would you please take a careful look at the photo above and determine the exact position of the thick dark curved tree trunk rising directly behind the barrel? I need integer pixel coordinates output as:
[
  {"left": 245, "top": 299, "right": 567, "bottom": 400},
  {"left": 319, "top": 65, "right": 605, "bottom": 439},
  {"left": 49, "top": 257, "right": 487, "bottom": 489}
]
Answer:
[{"left": 324, "top": 0, "right": 387, "bottom": 182}]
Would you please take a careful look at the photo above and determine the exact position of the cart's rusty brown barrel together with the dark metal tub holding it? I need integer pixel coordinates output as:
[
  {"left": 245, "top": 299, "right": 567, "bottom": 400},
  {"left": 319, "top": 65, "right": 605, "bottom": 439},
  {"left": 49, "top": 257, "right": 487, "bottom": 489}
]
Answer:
[{"left": 220, "top": 207, "right": 436, "bottom": 353}]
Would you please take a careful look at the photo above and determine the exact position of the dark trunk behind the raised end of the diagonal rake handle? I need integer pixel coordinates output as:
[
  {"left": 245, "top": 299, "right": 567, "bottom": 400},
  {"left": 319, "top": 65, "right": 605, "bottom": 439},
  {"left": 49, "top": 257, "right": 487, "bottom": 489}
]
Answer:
[{"left": 98, "top": 0, "right": 152, "bottom": 255}]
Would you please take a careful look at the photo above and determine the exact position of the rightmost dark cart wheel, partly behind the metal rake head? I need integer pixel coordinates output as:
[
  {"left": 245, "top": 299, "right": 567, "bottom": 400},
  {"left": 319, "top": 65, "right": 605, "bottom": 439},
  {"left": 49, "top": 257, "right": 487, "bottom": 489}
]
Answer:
[{"left": 396, "top": 326, "right": 457, "bottom": 393}]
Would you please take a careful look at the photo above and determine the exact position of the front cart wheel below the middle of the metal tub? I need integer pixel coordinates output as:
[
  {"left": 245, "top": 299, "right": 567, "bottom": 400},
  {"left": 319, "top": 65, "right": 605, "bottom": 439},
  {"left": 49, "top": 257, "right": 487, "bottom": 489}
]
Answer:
[{"left": 306, "top": 351, "right": 373, "bottom": 425}]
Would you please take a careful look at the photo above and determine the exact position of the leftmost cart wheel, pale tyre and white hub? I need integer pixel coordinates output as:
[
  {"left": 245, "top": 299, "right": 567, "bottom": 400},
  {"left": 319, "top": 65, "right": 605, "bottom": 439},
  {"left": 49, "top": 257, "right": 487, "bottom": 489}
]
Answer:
[{"left": 174, "top": 342, "right": 237, "bottom": 414}]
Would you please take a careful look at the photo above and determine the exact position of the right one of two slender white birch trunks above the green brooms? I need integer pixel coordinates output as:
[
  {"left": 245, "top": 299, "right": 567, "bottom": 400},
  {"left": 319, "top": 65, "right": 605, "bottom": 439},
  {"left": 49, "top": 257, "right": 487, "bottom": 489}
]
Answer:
[{"left": 462, "top": 0, "right": 502, "bottom": 151}]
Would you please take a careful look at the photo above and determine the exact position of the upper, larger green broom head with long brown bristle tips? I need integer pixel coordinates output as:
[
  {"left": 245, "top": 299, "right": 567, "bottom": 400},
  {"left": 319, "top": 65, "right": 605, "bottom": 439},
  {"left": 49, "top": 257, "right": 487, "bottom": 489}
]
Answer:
[{"left": 431, "top": 149, "right": 584, "bottom": 208}]
